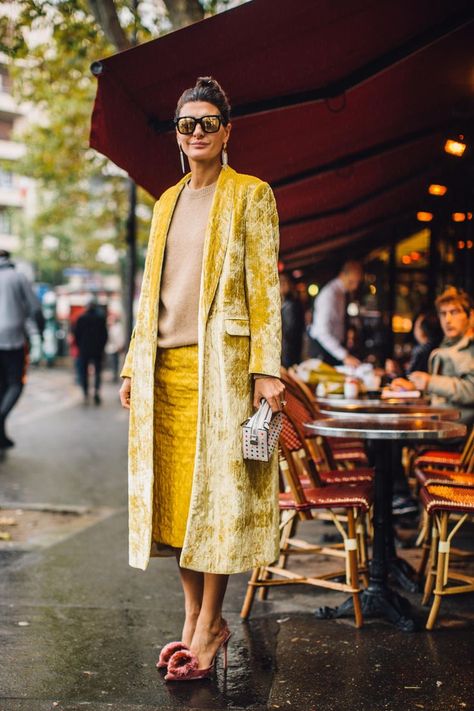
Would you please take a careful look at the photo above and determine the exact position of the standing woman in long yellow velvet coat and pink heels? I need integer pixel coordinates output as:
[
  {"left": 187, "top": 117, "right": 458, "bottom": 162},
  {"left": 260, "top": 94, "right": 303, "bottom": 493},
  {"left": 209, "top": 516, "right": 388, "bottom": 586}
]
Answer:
[{"left": 120, "top": 78, "right": 284, "bottom": 679}]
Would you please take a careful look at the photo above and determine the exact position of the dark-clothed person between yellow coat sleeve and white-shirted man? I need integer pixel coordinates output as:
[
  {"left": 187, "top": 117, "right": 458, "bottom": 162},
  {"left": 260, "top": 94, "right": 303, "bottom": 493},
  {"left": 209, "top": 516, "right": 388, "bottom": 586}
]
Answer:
[{"left": 280, "top": 274, "right": 305, "bottom": 368}]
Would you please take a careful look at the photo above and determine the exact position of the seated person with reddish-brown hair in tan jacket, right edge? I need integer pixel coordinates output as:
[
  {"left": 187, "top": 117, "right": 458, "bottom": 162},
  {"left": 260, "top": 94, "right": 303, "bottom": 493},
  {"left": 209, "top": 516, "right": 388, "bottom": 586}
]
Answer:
[{"left": 392, "top": 287, "right": 474, "bottom": 425}]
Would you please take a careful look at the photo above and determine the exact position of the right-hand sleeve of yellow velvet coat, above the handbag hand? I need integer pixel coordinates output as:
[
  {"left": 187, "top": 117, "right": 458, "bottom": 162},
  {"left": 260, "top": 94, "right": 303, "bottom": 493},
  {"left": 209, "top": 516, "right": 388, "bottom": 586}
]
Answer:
[{"left": 245, "top": 183, "right": 281, "bottom": 378}]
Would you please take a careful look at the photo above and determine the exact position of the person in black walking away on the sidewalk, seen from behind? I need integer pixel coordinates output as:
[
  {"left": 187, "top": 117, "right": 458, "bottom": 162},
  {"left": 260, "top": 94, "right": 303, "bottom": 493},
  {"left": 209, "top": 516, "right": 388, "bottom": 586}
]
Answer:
[{"left": 73, "top": 299, "right": 107, "bottom": 405}]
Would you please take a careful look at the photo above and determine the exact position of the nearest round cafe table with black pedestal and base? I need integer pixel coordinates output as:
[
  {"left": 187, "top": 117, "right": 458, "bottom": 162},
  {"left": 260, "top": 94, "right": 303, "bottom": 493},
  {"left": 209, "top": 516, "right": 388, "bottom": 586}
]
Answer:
[{"left": 305, "top": 415, "right": 466, "bottom": 632}]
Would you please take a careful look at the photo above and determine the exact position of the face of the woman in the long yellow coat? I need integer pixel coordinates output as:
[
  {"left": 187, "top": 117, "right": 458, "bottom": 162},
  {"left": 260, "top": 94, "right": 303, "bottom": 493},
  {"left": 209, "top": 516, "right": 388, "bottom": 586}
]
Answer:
[{"left": 176, "top": 101, "right": 231, "bottom": 163}]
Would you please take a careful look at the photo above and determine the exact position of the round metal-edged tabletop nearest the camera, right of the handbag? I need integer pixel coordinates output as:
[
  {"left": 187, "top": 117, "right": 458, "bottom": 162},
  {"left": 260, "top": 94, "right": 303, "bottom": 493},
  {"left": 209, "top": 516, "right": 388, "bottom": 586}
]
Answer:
[{"left": 305, "top": 415, "right": 466, "bottom": 440}]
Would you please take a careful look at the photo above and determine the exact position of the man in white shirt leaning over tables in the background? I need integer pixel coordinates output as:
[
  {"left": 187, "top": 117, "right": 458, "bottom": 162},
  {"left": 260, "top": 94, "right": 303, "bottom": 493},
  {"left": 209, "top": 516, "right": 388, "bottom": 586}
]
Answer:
[{"left": 309, "top": 261, "right": 363, "bottom": 367}]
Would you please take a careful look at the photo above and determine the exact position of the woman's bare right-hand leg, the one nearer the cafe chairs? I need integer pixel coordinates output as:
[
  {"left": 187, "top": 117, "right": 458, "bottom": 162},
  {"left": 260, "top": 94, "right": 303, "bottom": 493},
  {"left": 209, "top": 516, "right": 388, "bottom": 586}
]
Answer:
[{"left": 191, "top": 573, "right": 229, "bottom": 669}]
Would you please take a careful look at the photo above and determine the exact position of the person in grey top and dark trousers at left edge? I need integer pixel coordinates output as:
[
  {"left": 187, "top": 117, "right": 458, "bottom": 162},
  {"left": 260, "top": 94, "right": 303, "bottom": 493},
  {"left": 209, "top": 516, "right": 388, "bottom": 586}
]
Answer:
[{"left": 0, "top": 249, "right": 44, "bottom": 449}]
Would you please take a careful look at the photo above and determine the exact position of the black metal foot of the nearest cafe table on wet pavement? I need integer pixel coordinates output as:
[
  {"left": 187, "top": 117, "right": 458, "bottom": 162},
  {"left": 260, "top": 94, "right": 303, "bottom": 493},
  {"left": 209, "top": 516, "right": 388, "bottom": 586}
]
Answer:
[{"left": 314, "top": 587, "right": 416, "bottom": 632}]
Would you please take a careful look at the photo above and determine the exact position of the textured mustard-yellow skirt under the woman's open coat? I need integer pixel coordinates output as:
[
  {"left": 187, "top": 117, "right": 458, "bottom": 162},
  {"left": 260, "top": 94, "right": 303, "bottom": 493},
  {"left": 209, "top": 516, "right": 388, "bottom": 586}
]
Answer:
[{"left": 153, "top": 345, "right": 198, "bottom": 548}]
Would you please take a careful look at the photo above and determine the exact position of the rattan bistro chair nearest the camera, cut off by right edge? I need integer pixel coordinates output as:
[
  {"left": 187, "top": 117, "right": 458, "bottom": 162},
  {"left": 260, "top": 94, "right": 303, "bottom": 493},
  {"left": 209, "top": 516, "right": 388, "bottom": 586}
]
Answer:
[{"left": 420, "top": 484, "right": 474, "bottom": 630}]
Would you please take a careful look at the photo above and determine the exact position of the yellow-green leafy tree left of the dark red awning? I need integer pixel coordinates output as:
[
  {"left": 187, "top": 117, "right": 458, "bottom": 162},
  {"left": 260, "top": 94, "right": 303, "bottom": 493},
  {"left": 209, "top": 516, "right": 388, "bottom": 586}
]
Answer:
[{"left": 0, "top": 0, "right": 244, "bottom": 281}]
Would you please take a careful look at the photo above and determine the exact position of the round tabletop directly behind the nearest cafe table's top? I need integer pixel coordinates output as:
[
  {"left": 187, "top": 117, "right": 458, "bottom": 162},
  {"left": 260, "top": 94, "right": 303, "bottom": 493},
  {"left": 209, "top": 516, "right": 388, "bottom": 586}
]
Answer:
[{"left": 320, "top": 400, "right": 460, "bottom": 421}]
